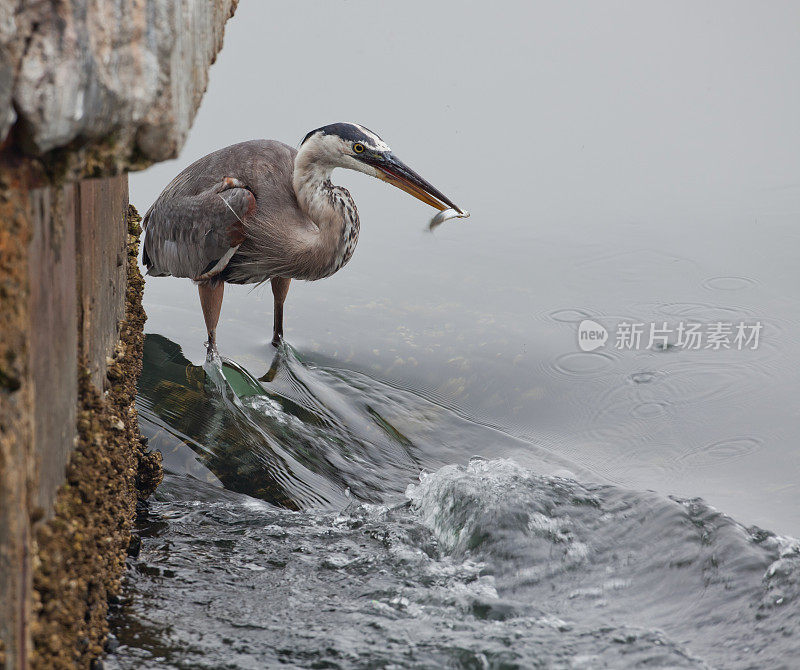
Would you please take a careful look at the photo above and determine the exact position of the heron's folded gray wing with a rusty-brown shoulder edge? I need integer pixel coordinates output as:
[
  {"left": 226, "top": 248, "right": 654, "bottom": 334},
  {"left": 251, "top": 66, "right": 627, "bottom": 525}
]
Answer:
[{"left": 142, "top": 177, "right": 256, "bottom": 279}]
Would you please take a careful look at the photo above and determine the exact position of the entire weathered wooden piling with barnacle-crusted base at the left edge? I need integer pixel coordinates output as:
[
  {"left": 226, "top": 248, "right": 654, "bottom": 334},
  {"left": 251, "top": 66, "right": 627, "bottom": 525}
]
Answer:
[{"left": 0, "top": 0, "right": 237, "bottom": 669}]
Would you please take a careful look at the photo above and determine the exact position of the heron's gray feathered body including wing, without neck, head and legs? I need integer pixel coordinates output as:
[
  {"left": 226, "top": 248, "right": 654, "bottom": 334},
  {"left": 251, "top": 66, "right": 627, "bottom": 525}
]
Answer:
[{"left": 142, "top": 140, "right": 302, "bottom": 283}]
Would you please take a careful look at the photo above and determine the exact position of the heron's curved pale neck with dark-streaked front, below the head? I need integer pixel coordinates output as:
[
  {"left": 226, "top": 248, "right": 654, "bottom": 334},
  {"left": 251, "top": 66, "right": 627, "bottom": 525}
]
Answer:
[{"left": 292, "top": 147, "right": 360, "bottom": 274}]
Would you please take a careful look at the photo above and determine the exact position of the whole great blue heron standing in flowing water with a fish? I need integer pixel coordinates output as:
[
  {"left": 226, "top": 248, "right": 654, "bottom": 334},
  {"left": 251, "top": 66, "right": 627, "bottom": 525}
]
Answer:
[{"left": 142, "top": 123, "right": 461, "bottom": 356}]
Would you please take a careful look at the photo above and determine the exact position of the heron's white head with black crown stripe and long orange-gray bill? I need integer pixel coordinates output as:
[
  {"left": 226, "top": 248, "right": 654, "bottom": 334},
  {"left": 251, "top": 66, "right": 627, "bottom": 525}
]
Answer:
[{"left": 298, "top": 123, "right": 462, "bottom": 212}]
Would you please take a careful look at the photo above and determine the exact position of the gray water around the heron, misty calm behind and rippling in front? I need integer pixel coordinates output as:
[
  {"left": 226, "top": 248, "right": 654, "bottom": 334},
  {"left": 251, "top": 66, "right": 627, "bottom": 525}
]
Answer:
[{"left": 106, "top": 2, "right": 800, "bottom": 668}]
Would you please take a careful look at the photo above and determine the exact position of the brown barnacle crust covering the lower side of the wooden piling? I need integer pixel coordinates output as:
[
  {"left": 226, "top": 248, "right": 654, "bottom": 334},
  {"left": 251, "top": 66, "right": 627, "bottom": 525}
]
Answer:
[{"left": 31, "top": 207, "right": 161, "bottom": 670}]
